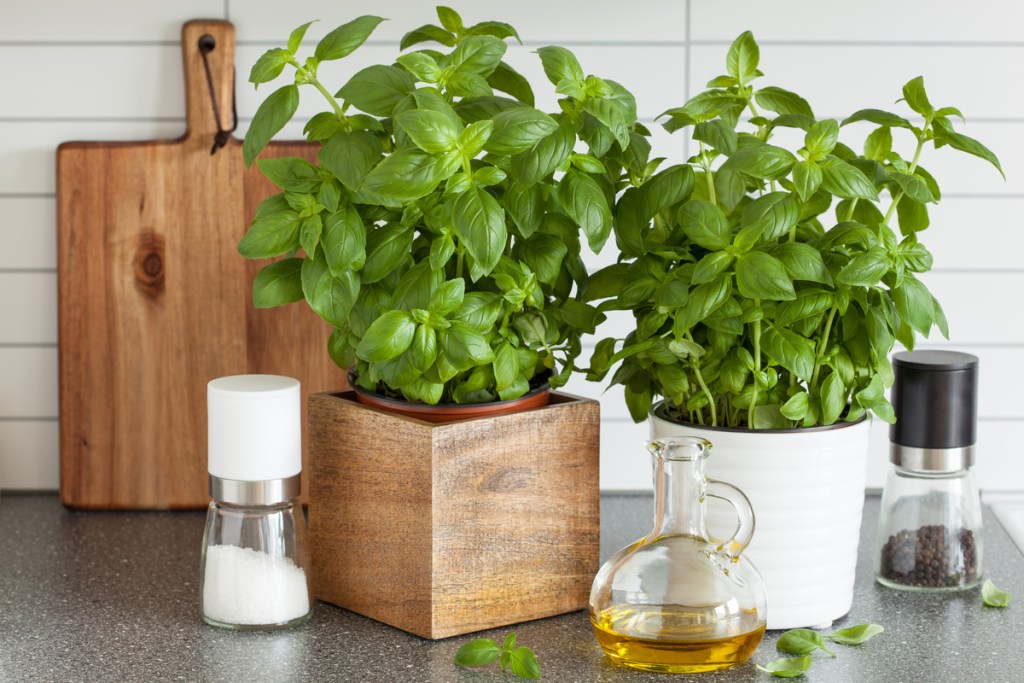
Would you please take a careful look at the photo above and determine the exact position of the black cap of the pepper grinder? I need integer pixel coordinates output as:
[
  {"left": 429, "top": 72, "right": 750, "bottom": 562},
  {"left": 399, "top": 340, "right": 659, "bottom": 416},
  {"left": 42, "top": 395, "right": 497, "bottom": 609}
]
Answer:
[{"left": 889, "top": 350, "right": 978, "bottom": 449}]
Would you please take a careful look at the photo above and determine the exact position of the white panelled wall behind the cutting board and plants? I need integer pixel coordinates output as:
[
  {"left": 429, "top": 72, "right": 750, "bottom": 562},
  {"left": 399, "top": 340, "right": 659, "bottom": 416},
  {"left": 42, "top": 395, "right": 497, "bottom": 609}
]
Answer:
[{"left": 0, "top": 0, "right": 1024, "bottom": 490}]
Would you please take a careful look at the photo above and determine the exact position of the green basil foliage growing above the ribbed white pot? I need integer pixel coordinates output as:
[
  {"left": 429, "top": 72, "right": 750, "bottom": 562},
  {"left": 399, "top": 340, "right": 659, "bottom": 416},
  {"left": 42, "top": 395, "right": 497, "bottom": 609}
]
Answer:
[{"left": 587, "top": 32, "right": 1001, "bottom": 429}]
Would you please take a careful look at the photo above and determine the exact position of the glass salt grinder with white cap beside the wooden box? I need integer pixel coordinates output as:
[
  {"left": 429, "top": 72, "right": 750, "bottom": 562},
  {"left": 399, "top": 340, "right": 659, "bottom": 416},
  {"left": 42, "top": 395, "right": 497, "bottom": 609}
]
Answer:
[{"left": 200, "top": 375, "right": 312, "bottom": 631}]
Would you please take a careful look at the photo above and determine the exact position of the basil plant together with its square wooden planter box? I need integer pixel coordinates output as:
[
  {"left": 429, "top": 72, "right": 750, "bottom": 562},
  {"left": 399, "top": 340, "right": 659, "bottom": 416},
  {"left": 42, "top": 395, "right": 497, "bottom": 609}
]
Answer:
[{"left": 239, "top": 7, "right": 648, "bottom": 637}]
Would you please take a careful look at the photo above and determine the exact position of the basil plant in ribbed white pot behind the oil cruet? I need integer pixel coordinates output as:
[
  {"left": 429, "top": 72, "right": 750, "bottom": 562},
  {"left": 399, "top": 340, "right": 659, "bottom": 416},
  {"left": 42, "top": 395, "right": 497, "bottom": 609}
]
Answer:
[{"left": 588, "top": 32, "right": 1001, "bottom": 629}]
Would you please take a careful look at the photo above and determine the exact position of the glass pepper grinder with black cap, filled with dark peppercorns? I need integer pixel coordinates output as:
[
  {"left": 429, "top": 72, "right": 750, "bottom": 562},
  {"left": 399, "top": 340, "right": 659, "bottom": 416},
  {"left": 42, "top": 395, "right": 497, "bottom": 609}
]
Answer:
[{"left": 874, "top": 350, "right": 982, "bottom": 591}]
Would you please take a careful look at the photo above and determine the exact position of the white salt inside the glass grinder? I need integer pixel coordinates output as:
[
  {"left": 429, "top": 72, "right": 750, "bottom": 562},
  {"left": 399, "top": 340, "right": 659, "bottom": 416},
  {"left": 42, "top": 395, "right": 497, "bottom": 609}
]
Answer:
[{"left": 203, "top": 546, "right": 309, "bottom": 626}]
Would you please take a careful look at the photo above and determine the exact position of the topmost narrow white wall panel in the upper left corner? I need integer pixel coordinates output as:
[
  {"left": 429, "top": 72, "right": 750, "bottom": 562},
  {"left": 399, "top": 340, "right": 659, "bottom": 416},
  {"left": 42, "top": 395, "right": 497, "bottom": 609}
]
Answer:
[{"left": 0, "top": 0, "right": 224, "bottom": 41}]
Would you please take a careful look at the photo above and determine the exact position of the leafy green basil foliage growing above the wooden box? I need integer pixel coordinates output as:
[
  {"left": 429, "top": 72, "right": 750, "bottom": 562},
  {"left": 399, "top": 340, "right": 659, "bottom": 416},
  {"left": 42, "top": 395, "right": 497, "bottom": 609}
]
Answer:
[{"left": 239, "top": 7, "right": 649, "bottom": 403}]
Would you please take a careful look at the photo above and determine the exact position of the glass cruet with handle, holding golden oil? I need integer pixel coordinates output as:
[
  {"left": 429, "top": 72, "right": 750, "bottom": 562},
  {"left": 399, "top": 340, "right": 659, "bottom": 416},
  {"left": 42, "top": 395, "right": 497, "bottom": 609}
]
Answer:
[{"left": 590, "top": 436, "right": 766, "bottom": 674}]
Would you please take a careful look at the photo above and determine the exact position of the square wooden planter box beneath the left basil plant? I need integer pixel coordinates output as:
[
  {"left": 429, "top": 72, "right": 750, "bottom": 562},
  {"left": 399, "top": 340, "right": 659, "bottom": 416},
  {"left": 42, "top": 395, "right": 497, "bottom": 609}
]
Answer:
[{"left": 309, "top": 392, "right": 600, "bottom": 638}]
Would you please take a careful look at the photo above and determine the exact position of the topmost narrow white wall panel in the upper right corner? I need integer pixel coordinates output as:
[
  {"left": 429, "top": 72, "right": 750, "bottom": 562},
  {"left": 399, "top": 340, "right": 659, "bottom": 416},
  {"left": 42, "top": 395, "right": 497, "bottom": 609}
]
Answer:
[{"left": 689, "top": 0, "right": 1024, "bottom": 44}]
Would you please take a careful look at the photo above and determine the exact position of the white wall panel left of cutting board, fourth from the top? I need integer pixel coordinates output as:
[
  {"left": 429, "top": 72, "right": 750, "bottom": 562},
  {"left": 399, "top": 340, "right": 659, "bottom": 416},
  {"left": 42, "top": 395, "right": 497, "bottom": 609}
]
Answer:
[{"left": 0, "top": 197, "right": 57, "bottom": 270}]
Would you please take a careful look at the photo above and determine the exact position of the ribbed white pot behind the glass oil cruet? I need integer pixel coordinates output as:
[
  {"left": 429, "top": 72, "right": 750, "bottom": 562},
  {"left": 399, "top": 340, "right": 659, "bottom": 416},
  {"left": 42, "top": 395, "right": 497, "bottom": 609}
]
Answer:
[{"left": 650, "top": 405, "right": 871, "bottom": 629}]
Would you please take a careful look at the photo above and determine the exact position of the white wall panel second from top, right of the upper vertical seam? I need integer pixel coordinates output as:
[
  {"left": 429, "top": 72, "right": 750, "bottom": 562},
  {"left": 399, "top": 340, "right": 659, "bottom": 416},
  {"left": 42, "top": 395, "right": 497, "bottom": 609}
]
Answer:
[{"left": 690, "top": 44, "right": 1024, "bottom": 122}]
